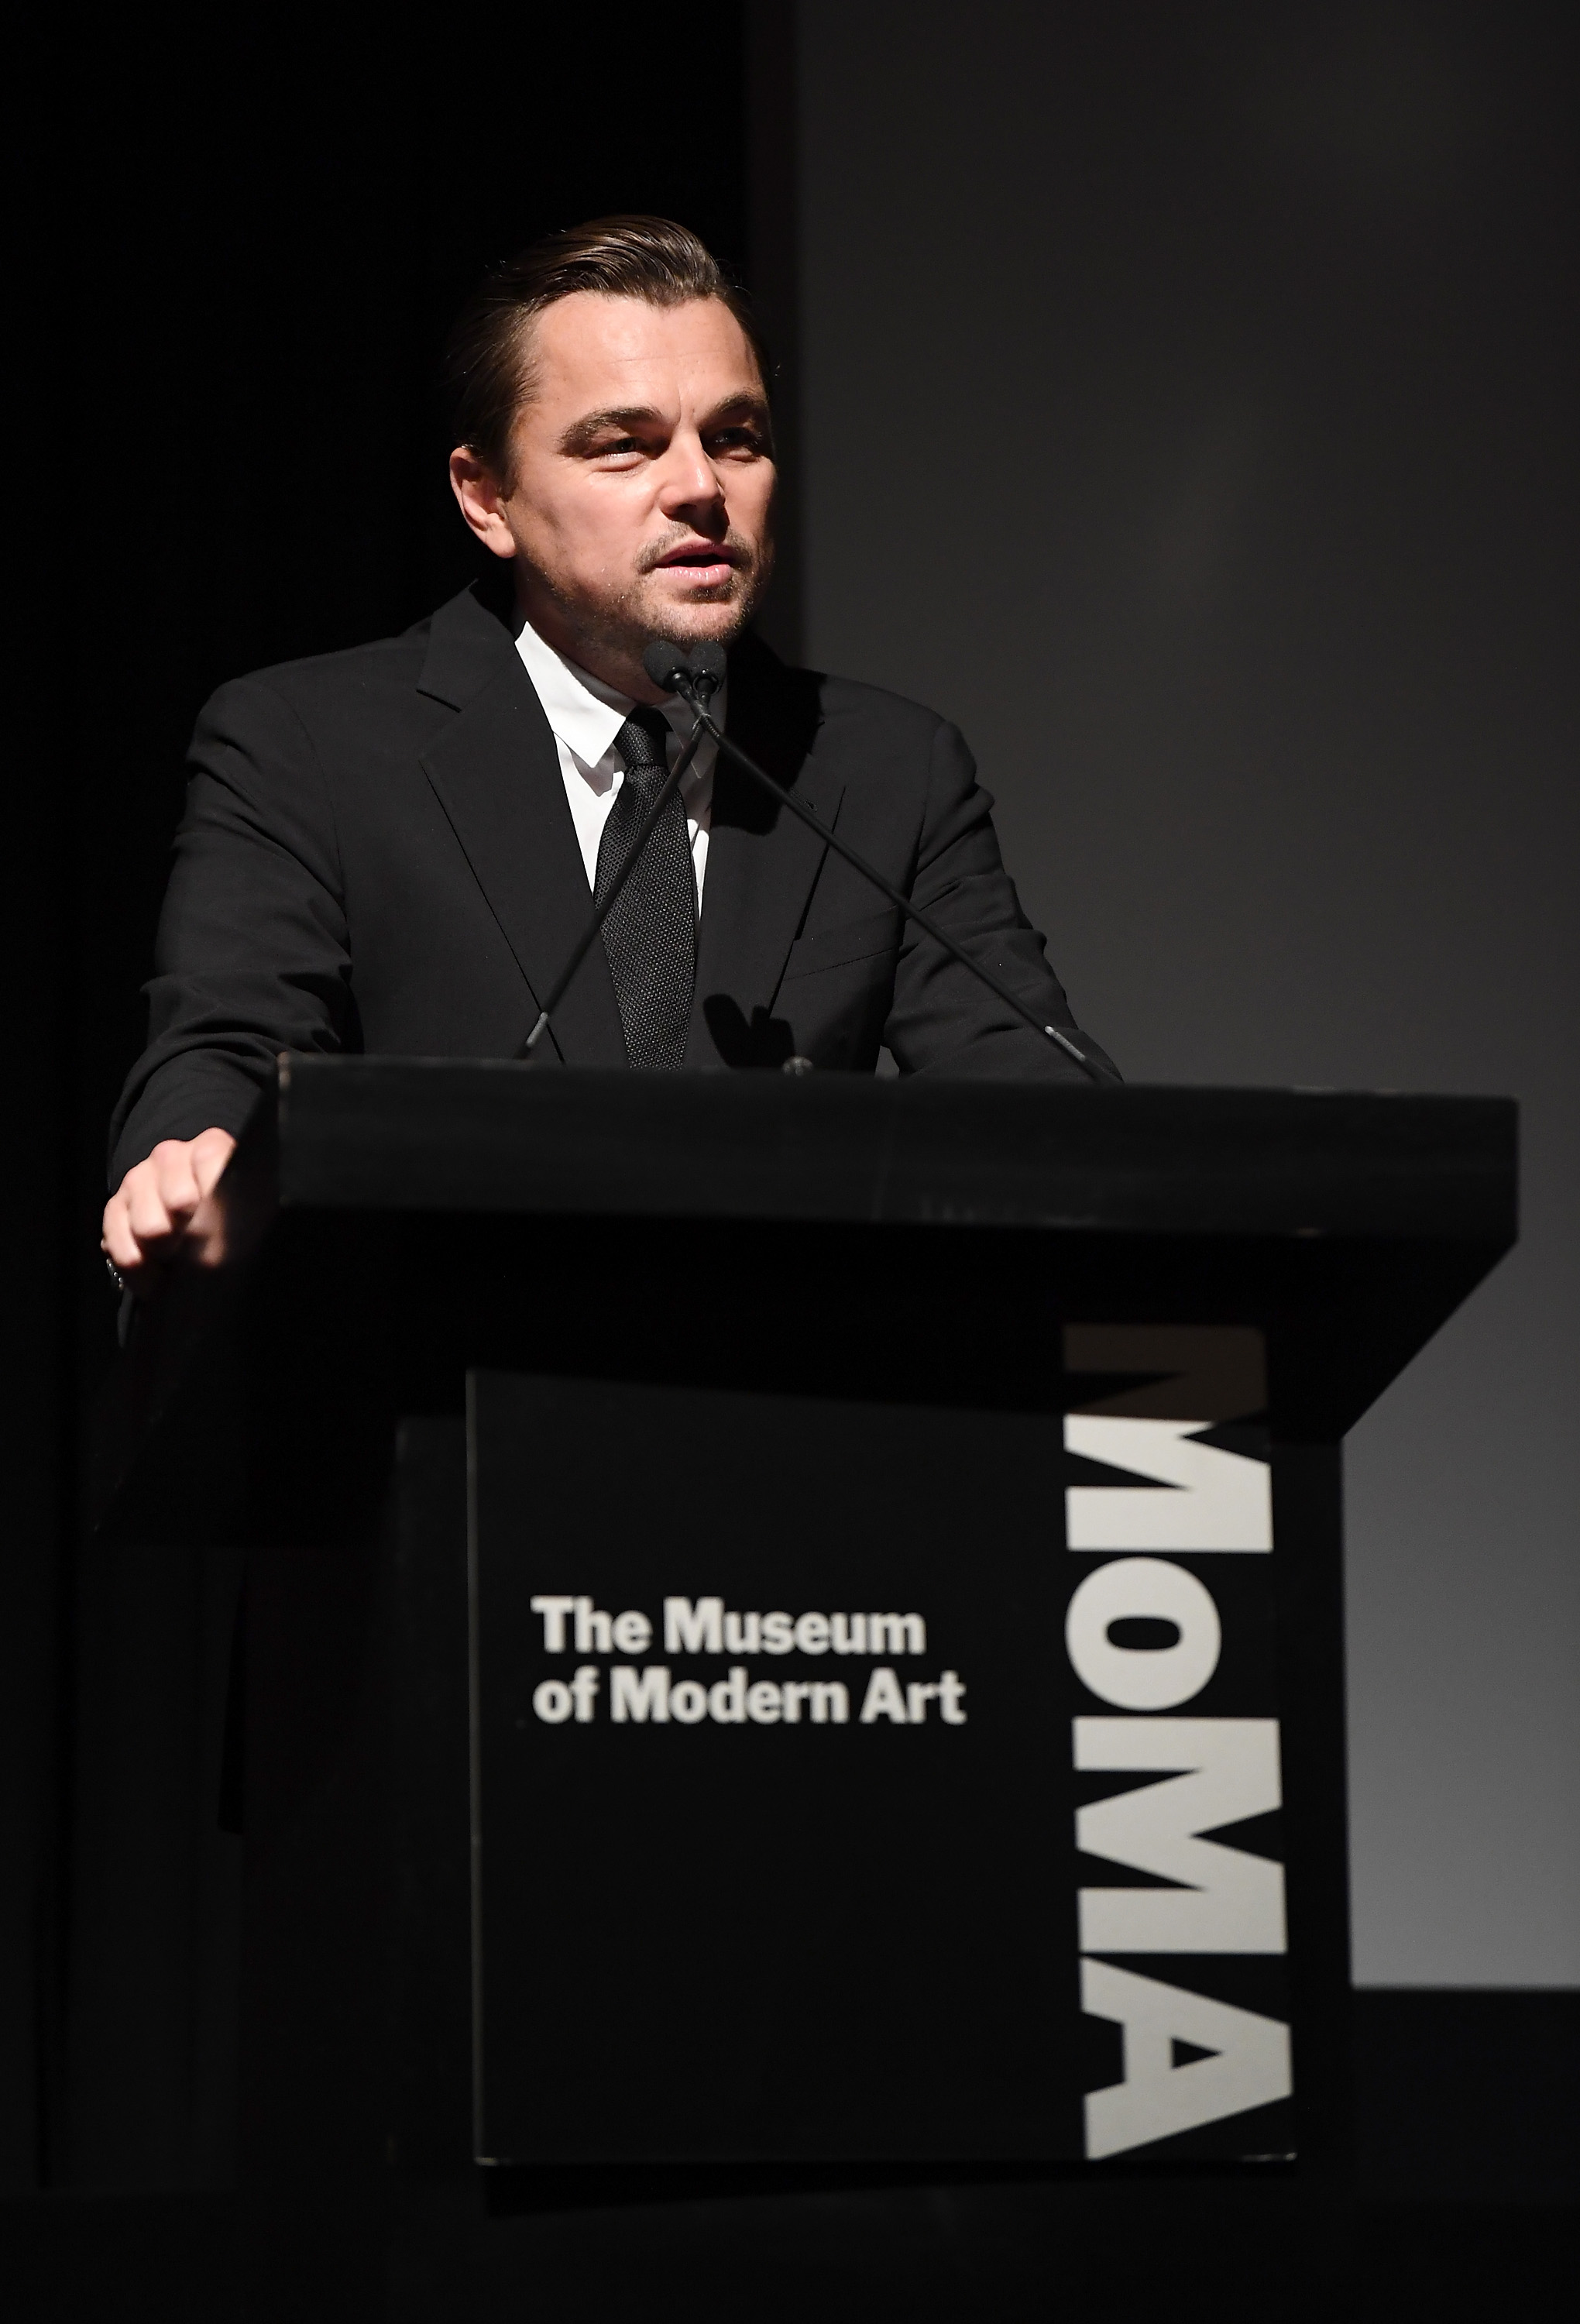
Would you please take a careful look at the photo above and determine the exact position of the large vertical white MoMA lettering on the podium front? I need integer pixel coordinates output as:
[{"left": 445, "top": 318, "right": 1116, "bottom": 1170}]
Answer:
[{"left": 1064, "top": 1325, "right": 1292, "bottom": 2161}]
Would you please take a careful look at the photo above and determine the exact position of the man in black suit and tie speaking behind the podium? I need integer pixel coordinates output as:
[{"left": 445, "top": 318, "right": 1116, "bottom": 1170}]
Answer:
[{"left": 105, "top": 218, "right": 1101, "bottom": 1287}]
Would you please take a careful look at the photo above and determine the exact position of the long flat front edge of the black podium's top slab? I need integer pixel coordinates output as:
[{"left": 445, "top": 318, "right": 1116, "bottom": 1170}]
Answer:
[{"left": 274, "top": 1057, "right": 1517, "bottom": 1264}]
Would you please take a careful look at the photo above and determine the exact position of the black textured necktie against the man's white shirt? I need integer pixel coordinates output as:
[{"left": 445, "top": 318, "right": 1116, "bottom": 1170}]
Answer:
[{"left": 592, "top": 709, "right": 697, "bottom": 1074}]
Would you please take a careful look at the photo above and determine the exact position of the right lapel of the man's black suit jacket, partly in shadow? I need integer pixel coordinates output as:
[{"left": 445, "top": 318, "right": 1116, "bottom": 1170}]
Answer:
[{"left": 685, "top": 639, "right": 843, "bottom": 1067}]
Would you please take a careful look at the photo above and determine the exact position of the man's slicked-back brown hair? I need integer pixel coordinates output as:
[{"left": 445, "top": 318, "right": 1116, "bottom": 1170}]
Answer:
[{"left": 444, "top": 216, "right": 769, "bottom": 490}]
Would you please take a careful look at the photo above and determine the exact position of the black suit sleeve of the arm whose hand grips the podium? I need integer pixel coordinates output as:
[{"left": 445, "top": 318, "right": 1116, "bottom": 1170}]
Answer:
[{"left": 109, "top": 679, "right": 356, "bottom": 1188}]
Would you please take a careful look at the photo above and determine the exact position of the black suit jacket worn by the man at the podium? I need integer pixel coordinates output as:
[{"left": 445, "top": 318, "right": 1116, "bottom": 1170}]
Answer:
[{"left": 112, "top": 588, "right": 1111, "bottom": 1185}]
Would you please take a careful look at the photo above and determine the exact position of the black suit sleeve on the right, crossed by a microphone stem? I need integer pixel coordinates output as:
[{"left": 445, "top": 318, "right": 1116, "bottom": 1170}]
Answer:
[{"left": 883, "top": 725, "right": 1108, "bottom": 1083}]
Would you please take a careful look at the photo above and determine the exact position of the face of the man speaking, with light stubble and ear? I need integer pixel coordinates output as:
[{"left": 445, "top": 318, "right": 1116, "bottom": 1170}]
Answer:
[{"left": 451, "top": 290, "right": 774, "bottom": 690}]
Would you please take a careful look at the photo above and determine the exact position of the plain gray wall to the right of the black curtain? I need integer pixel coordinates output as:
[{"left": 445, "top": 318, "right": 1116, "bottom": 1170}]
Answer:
[{"left": 799, "top": 0, "right": 1580, "bottom": 1985}]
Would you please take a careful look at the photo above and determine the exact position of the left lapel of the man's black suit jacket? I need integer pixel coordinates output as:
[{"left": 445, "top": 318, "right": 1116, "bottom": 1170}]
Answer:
[{"left": 418, "top": 593, "right": 627, "bottom": 1067}]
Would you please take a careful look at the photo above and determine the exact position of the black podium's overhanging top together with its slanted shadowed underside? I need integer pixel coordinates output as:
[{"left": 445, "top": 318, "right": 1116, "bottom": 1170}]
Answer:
[{"left": 93, "top": 1057, "right": 1517, "bottom": 1541}]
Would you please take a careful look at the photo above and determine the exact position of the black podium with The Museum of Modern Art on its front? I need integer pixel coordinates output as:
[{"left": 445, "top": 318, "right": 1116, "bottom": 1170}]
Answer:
[{"left": 95, "top": 1057, "right": 1515, "bottom": 2317}]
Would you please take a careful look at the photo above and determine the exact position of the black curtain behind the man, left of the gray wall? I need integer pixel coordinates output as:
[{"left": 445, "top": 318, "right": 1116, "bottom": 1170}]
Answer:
[{"left": 0, "top": 5, "right": 757, "bottom": 2189}]
